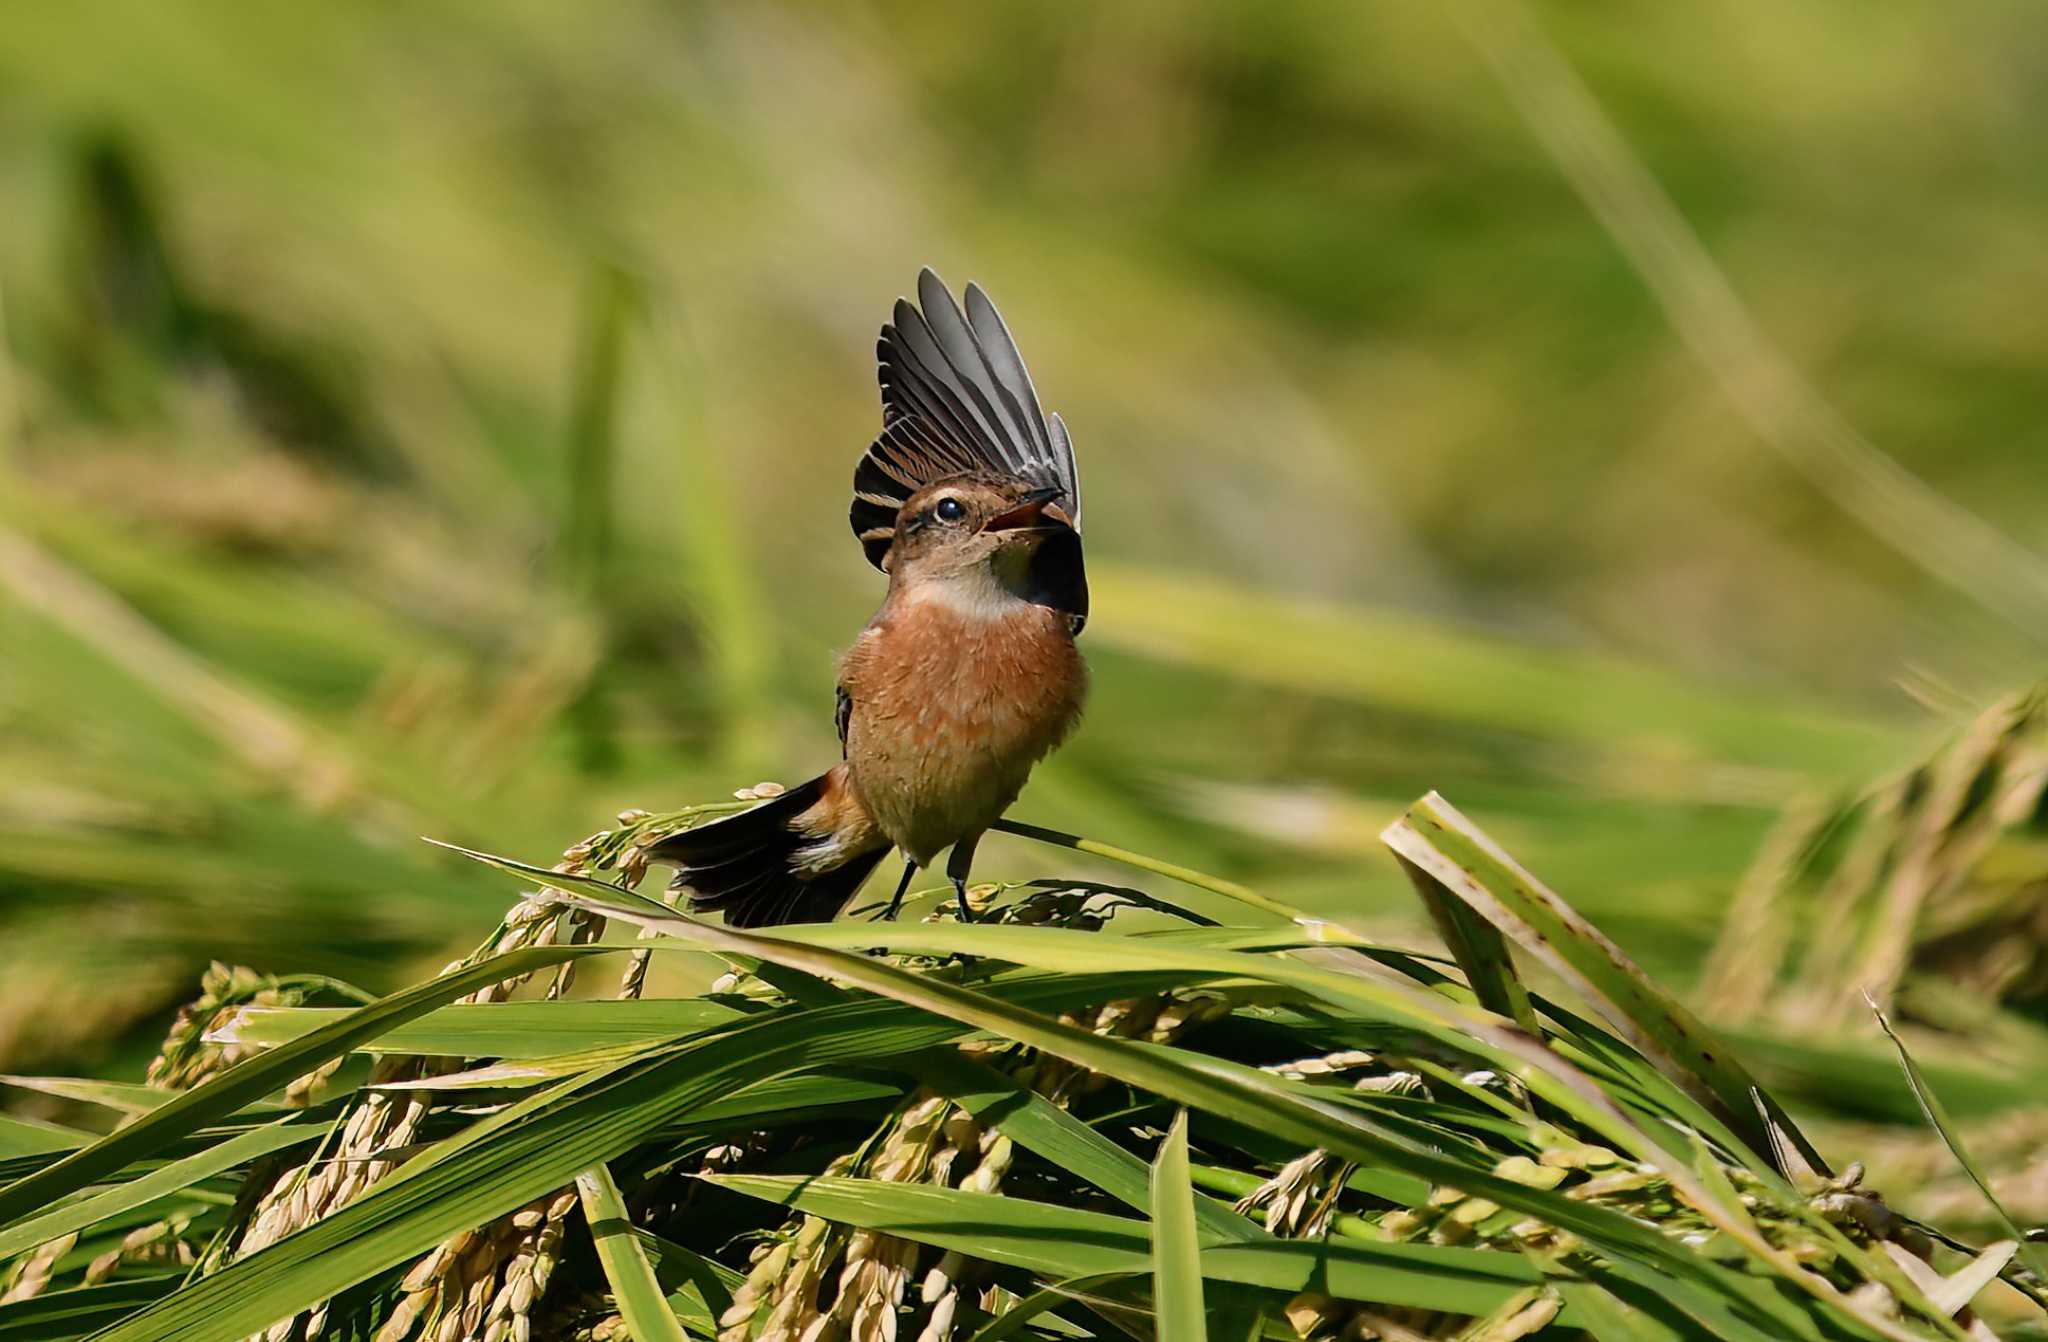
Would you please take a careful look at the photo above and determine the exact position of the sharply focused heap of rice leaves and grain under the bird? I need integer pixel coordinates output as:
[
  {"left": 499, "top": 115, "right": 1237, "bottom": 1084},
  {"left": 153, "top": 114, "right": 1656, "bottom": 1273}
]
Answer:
[{"left": 0, "top": 795, "right": 2048, "bottom": 1342}]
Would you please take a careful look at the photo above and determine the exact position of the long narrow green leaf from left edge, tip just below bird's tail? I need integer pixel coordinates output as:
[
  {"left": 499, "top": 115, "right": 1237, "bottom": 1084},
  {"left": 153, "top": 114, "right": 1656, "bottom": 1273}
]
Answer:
[{"left": 0, "top": 947, "right": 604, "bottom": 1225}]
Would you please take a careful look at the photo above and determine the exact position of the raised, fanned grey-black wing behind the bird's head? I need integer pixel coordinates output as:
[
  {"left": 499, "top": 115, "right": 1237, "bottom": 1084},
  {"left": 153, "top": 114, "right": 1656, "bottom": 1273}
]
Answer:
[{"left": 850, "top": 268, "right": 1081, "bottom": 568}]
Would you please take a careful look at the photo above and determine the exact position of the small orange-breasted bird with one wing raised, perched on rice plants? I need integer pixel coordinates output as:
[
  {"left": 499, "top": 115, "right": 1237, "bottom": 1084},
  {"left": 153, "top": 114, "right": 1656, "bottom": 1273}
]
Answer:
[{"left": 647, "top": 268, "right": 1087, "bottom": 928}]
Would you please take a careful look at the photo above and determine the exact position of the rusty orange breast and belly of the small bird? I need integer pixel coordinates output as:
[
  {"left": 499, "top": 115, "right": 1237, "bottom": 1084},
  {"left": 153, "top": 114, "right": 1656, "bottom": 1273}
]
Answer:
[{"left": 840, "top": 600, "right": 1087, "bottom": 865}]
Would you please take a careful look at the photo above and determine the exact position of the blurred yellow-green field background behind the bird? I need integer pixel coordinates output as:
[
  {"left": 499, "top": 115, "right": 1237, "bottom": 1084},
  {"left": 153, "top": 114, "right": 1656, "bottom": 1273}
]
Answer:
[{"left": 0, "top": 0, "right": 2048, "bottom": 1072}]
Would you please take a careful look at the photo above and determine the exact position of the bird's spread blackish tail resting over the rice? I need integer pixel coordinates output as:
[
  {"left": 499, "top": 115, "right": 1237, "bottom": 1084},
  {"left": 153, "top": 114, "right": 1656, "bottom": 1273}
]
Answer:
[{"left": 649, "top": 774, "right": 889, "bottom": 928}]
